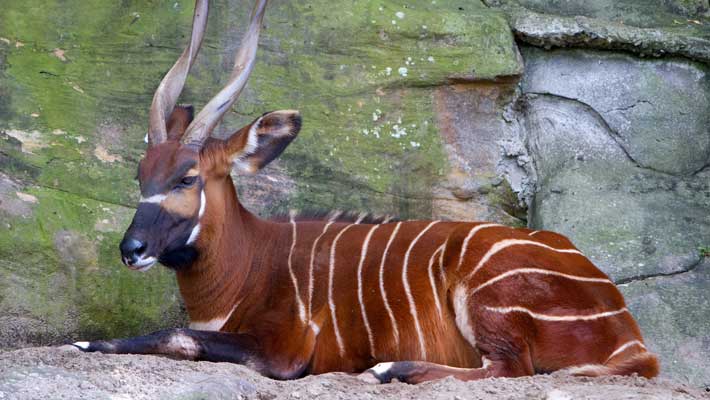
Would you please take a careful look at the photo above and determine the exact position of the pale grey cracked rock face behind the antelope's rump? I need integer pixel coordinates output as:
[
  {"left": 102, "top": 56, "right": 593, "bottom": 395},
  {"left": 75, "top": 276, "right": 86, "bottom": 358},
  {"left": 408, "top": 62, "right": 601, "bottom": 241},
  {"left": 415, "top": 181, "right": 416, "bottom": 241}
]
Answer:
[{"left": 517, "top": 48, "right": 710, "bottom": 384}]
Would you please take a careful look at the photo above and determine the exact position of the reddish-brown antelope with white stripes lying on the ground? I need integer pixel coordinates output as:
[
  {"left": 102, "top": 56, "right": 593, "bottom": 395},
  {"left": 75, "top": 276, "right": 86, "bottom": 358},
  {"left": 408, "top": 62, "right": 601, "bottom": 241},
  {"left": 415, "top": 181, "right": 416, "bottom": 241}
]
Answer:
[{"left": 74, "top": 0, "right": 659, "bottom": 383}]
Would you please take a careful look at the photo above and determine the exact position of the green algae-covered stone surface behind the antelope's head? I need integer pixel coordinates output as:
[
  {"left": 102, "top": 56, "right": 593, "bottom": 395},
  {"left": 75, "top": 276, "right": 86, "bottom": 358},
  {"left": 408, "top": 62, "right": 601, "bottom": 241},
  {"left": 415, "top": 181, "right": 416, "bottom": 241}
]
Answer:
[{"left": 0, "top": 0, "right": 522, "bottom": 346}]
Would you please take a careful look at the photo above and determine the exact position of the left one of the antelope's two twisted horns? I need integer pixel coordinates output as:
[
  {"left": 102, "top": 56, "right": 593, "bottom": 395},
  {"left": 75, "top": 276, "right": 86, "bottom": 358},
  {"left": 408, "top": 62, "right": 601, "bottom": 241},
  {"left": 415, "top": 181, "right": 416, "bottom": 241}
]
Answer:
[{"left": 148, "top": 0, "right": 209, "bottom": 145}]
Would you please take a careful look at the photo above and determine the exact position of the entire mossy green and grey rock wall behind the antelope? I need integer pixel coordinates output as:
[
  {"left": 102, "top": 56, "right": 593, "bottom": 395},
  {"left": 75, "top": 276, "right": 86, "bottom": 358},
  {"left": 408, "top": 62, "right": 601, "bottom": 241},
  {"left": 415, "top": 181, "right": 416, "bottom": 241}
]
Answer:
[{"left": 0, "top": 0, "right": 710, "bottom": 385}]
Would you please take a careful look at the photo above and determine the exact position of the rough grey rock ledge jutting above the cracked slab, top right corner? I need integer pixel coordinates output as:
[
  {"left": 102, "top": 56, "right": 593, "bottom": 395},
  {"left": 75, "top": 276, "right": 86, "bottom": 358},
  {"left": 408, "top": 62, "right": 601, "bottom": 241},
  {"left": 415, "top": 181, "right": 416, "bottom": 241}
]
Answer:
[{"left": 484, "top": 0, "right": 710, "bottom": 62}]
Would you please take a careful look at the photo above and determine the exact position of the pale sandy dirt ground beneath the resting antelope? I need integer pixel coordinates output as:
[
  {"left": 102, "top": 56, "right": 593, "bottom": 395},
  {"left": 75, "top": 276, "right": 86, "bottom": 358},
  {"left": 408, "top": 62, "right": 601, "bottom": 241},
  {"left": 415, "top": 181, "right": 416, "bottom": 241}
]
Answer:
[{"left": 0, "top": 347, "right": 710, "bottom": 400}]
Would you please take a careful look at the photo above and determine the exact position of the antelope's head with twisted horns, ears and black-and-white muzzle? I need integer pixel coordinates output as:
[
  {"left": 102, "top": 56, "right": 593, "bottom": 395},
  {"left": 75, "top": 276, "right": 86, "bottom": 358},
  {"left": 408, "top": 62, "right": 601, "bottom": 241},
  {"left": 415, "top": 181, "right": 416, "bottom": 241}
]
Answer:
[{"left": 120, "top": 0, "right": 301, "bottom": 271}]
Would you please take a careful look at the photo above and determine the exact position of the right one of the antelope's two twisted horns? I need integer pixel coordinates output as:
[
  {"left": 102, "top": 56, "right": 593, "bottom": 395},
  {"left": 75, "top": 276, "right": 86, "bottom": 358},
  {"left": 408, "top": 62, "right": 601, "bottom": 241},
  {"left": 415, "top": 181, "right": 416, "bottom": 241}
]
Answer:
[{"left": 182, "top": 0, "right": 267, "bottom": 147}]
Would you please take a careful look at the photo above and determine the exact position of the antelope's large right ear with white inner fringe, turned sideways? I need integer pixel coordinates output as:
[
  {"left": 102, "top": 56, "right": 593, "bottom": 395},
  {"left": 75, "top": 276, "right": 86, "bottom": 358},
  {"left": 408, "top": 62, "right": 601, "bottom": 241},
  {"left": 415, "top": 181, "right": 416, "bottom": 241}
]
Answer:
[{"left": 226, "top": 110, "right": 301, "bottom": 173}]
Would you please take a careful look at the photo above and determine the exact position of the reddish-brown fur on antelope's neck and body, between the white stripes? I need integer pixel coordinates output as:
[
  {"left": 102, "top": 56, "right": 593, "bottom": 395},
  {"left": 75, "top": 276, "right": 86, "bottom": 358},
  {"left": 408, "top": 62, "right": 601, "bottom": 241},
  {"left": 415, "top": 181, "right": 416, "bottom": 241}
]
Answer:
[{"left": 178, "top": 177, "right": 658, "bottom": 377}]
